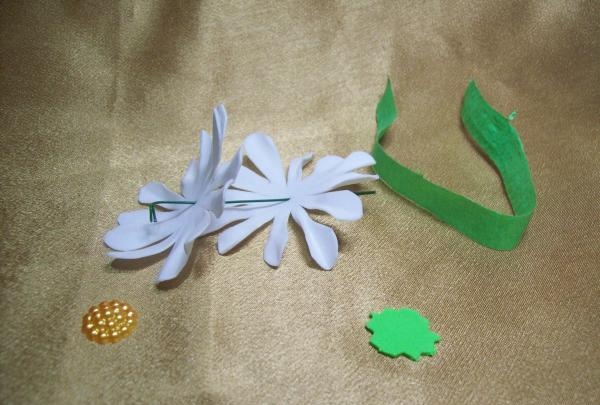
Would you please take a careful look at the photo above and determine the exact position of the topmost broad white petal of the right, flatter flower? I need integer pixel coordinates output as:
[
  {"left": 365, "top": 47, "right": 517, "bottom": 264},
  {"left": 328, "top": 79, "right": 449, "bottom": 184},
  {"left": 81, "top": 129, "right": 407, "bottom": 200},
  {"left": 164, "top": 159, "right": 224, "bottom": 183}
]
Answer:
[{"left": 244, "top": 133, "right": 285, "bottom": 186}]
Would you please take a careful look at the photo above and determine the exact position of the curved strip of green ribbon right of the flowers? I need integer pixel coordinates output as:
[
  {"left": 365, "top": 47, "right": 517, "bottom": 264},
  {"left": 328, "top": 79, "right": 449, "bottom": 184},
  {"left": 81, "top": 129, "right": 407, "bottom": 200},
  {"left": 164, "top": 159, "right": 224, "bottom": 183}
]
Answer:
[{"left": 373, "top": 80, "right": 536, "bottom": 250}]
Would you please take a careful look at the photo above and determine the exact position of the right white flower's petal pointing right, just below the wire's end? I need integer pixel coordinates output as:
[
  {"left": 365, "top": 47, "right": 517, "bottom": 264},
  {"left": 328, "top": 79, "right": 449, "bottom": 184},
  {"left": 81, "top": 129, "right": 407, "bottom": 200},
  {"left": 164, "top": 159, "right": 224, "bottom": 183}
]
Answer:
[{"left": 298, "top": 190, "right": 363, "bottom": 221}]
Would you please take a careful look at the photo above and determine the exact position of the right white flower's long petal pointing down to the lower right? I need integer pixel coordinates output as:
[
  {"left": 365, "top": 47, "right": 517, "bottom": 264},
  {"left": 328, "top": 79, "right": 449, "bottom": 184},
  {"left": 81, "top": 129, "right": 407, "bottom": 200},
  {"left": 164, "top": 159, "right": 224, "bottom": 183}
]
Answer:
[{"left": 292, "top": 206, "right": 338, "bottom": 270}]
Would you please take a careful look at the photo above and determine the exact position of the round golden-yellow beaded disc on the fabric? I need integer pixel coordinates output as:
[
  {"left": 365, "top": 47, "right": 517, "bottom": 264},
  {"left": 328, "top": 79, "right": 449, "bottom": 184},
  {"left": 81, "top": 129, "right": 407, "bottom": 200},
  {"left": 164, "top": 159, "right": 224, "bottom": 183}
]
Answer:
[{"left": 81, "top": 300, "right": 138, "bottom": 344}]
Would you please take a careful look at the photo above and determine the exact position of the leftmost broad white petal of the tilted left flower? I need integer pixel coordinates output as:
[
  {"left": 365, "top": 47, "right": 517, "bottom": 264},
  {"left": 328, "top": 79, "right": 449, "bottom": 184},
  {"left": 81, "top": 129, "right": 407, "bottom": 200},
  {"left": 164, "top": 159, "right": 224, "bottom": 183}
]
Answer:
[{"left": 104, "top": 211, "right": 188, "bottom": 250}]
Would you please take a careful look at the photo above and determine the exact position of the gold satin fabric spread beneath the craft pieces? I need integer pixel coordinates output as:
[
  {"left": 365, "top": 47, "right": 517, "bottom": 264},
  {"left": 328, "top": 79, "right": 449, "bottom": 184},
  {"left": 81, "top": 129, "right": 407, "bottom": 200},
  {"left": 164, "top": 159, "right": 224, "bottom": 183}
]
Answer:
[{"left": 0, "top": 0, "right": 600, "bottom": 405}]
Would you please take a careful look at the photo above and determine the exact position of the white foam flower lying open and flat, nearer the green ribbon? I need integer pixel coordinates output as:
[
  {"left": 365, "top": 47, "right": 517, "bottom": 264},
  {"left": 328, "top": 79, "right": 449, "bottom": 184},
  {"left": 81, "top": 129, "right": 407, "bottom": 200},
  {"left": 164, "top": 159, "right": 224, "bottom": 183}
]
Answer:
[{"left": 217, "top": 134, "right": 378, "bottom": 270}]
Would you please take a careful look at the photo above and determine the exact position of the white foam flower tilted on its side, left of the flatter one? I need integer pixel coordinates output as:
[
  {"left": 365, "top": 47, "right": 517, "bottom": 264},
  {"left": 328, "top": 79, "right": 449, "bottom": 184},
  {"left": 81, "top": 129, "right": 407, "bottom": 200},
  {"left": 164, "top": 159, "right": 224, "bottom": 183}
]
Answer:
[{"left": 104, "top": 105, "right": 243, "bottom": 282}]
